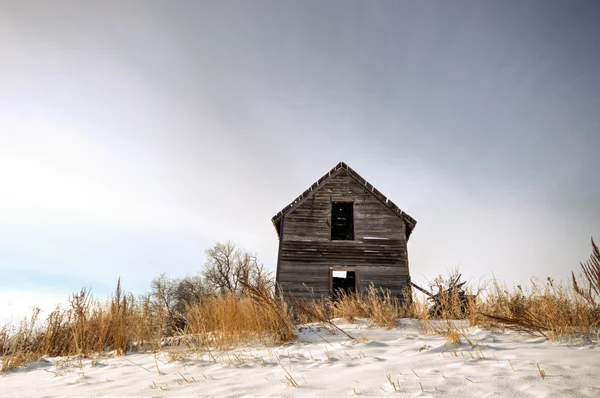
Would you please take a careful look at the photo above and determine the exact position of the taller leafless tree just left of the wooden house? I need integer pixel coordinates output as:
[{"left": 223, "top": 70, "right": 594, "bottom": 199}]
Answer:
[{"left": 203, "top": 241, "right": 273, "bottom": 294}]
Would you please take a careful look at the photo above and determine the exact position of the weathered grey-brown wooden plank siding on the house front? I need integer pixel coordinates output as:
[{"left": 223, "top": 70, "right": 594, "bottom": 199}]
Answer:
[{"left": 277, "top": 170, "right": 409, "bottom": 298}]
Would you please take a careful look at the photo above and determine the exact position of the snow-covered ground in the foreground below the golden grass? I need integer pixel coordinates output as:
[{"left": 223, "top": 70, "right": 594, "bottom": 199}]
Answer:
[{"left": 0, "top": 319, "right": 600, "bottom": 397}]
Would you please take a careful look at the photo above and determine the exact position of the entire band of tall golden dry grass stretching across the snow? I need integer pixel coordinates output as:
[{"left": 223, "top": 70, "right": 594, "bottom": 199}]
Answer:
[{"left": 0, "top": 241, "right": 600, "bottom": 372}]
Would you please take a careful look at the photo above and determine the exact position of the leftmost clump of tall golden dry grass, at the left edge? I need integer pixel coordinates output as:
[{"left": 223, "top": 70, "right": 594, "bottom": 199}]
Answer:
[{"left": 0, "top": 282, "right": 158, "bottom": 372}]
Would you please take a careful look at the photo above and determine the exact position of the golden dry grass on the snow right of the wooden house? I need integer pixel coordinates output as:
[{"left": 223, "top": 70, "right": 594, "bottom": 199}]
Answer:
[{"left": 411, "top": 279, "right": 600, "bottom": 344}]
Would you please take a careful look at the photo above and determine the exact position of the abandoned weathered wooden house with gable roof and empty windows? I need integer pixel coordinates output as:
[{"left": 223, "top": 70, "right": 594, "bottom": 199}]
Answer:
[{"left": 272, "top": 162, "right": 416, "bottom": 299}]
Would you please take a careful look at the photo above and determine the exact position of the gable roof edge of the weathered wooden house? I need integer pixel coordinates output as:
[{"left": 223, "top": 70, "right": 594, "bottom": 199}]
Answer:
[{"left": 271, "top": 162, "right": 417, "bottom": 240}]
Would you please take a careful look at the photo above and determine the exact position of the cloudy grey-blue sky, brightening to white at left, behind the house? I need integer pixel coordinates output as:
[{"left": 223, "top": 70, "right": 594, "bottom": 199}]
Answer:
[{"left": 0, "top": 0, "right": 600, "bottom": 323}]
